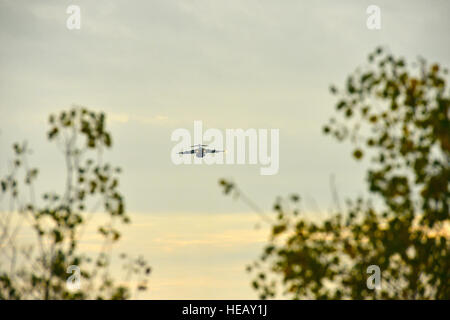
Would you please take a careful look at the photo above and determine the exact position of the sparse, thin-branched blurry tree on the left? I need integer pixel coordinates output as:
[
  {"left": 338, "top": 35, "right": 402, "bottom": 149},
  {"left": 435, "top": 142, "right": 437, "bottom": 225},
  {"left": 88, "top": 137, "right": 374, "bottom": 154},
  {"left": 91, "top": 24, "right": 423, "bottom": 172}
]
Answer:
[{"left": 0, "top": 107, "right": 150, "bottom": 299}]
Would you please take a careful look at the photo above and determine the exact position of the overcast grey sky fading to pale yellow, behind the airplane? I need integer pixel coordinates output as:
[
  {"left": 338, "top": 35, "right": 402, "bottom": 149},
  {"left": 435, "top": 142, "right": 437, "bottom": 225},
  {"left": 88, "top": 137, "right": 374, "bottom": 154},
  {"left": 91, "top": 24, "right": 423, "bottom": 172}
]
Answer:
[{"left": 0, "top": 0, "right": 450, "bottom": 299}]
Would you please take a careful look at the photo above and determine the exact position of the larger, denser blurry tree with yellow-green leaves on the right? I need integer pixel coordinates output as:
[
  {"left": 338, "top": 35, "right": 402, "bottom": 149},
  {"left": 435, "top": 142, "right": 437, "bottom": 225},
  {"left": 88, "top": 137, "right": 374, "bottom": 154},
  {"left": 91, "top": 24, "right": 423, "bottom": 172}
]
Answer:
[{"left": 220, "top": 48, "right": 450, "bottom": 299}]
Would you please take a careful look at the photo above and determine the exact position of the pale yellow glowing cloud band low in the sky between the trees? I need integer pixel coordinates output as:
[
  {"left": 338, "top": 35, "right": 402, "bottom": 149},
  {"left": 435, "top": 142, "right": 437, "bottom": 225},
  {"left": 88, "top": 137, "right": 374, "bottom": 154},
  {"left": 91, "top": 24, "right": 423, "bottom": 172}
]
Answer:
[{"left": 4, "top": 213, "right": 268, "bottom": 299}]
